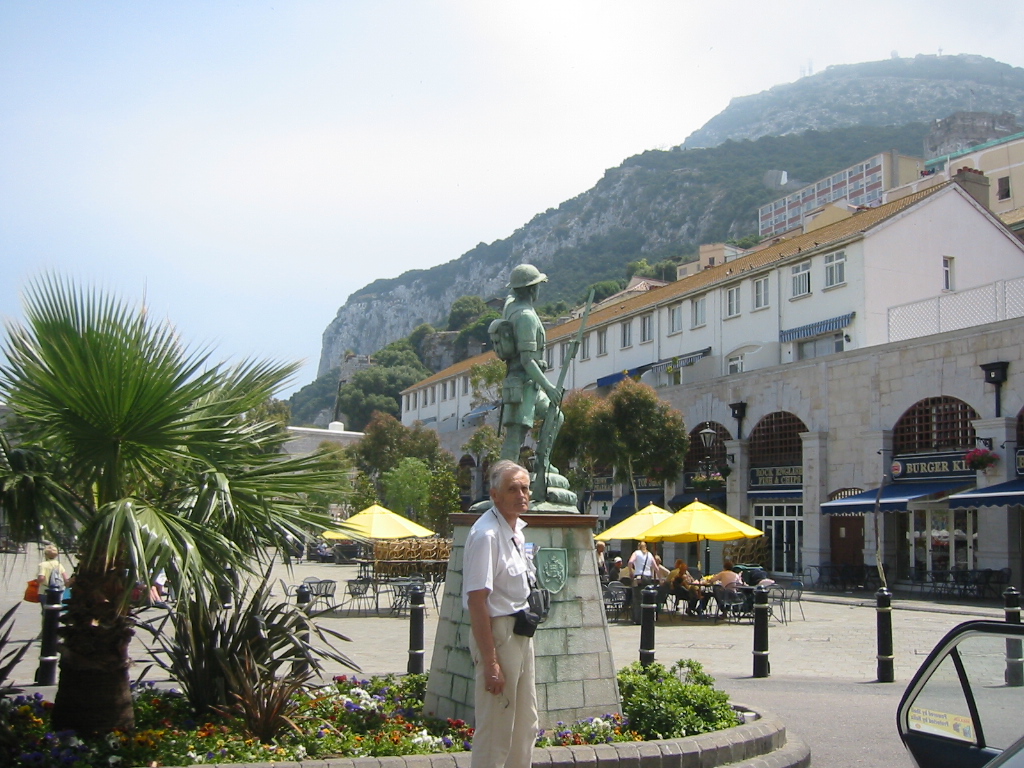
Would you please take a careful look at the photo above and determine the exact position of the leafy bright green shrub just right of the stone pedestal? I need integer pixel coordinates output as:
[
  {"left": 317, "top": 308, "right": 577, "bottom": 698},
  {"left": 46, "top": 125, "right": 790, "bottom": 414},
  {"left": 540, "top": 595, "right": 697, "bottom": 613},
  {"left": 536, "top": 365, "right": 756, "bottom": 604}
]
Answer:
[{"left": 618, "top": 659, "right": 739, "bottom": 740}]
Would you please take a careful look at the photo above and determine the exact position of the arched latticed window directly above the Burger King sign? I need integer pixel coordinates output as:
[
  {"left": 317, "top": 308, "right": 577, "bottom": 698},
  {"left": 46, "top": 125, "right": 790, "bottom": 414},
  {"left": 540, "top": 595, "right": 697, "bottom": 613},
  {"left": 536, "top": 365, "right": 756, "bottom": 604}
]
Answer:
[{"left": 893, "top": 396, "right": 979, "bottom": 456}]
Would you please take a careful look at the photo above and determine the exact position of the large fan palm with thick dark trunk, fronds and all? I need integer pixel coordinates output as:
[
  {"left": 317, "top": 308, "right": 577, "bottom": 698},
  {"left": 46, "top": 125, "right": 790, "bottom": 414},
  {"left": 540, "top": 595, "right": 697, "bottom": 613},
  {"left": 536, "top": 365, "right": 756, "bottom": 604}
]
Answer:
[{"left": 0, "top": 276, "right": 337, "bottom": 733}]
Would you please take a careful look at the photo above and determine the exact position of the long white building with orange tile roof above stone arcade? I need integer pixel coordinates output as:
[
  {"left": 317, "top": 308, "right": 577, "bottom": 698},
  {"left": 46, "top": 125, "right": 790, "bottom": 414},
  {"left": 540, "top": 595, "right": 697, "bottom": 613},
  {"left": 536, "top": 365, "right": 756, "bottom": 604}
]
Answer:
[{"left": 402, "top": 172, "right": 1024, "bottom": 575}]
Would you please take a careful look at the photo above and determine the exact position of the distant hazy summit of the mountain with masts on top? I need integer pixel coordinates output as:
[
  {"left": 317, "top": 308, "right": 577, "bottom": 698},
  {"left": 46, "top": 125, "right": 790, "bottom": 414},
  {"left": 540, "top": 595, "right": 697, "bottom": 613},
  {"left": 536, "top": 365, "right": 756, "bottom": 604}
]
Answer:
[{"left": 683, "top": 55, "right": 1024, "bottom": 148}]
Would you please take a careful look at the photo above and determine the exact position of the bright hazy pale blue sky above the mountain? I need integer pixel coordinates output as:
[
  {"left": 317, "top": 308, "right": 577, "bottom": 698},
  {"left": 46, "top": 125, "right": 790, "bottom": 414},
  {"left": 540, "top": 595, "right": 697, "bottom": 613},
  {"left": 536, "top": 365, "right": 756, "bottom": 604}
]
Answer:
[{"left": 0, "top": 0, "right": 1024, "bottom": 396}]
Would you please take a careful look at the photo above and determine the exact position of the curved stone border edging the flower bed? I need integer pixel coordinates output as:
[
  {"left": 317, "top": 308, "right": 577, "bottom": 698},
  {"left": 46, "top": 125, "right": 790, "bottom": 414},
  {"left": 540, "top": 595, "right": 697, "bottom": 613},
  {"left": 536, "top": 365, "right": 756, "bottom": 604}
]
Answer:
[{"left": 169, "top": 705, "right": 811, "bottom": 768}]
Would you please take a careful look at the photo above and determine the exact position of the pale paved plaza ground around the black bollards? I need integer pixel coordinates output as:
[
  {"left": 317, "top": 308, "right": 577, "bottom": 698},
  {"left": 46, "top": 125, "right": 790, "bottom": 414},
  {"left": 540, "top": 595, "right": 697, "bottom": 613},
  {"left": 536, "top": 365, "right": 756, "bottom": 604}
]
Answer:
[{"left": 0, "top": 551, "right": 1002, "bottom": 768}]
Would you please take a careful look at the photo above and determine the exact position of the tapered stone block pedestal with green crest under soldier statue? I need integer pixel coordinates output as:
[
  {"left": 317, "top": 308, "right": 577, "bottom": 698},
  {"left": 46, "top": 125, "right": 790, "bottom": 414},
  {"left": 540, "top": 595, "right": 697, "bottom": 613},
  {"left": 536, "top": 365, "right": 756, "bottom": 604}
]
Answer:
[{"left": 423, "top": 512, "right": 622, "bottom": 728}]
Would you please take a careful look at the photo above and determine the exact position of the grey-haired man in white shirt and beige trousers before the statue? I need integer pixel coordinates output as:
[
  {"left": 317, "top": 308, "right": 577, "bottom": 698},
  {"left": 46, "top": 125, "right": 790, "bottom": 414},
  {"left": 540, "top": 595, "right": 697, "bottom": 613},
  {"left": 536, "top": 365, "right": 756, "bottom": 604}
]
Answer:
[{"left": 462, "top": 460, "right": 538, "bottom": 768}]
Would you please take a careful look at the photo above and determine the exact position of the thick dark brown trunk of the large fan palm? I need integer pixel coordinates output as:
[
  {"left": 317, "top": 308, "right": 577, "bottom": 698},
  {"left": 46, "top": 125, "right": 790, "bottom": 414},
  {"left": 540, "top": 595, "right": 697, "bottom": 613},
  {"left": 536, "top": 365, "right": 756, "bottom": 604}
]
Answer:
[{"left": 51, "top": 568, "right": 135, "bottom": 735}]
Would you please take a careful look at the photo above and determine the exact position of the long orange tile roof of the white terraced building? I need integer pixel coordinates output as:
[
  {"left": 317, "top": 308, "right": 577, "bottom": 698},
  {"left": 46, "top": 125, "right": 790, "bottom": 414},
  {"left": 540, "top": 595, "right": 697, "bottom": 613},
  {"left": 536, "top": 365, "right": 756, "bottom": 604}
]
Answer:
[{"left": 402, "top": 181, "right": 954, "bottom": 394}]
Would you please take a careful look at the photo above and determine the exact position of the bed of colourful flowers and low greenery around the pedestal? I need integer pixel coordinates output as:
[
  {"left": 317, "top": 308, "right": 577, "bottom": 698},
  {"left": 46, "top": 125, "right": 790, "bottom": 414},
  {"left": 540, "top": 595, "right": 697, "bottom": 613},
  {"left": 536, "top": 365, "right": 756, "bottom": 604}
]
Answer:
[{"left": 0, "top": 662, "right": 737, "bottom": 768}]
